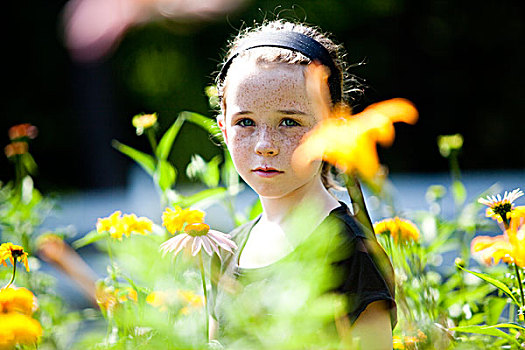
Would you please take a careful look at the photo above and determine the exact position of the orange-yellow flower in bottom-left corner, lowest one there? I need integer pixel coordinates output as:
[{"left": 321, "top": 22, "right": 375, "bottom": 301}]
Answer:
[{"left": 0, "top": 313, "right": 42, "bottom": 349}]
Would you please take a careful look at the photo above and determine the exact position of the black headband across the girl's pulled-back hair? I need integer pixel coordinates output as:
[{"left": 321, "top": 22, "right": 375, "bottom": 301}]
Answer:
[{"left": 219, "top": 31, "right": 342, "bottom": 104}]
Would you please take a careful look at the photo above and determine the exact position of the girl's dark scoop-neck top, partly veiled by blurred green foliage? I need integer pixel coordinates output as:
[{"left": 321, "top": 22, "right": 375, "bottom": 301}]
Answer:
[{"left": 209, "top": 202, "right": 397, "bottom": 344}]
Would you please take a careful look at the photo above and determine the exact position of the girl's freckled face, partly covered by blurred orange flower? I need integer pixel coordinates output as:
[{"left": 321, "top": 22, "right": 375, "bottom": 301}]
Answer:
[{"left": 218, "top": 60, "right": 321, "bottom": 198}]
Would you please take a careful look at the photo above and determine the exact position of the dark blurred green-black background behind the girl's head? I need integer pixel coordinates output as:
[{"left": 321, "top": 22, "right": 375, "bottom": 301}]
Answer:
[{"left": 0, "top": 0, "right": 525, "bottom": 191}]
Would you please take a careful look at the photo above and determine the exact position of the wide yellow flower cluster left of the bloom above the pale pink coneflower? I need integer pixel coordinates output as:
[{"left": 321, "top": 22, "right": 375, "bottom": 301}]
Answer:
[{"left": 97, "top": 211, "right": 153, "bottom": 240}]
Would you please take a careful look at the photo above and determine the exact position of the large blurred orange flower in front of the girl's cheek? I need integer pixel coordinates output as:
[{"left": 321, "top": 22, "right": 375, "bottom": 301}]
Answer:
[{"left": 292, "top": 64, "right": 418, "bottom": 180}]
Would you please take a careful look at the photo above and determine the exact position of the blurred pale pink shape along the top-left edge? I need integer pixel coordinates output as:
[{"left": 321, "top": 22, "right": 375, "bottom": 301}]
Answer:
[{"left": 63, "top": 0, "right": 244, "bottom": 62}]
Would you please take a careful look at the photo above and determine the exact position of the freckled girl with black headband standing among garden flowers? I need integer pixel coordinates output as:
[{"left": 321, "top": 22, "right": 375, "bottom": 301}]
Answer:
[{"left": 210, "top": 21, "right": 396, "bottom": 349}]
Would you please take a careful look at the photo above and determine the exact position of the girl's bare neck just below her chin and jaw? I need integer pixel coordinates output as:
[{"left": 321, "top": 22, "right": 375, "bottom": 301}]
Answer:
[{"left": 260, "top": 178, "right": 339, "bottom": 227}]
